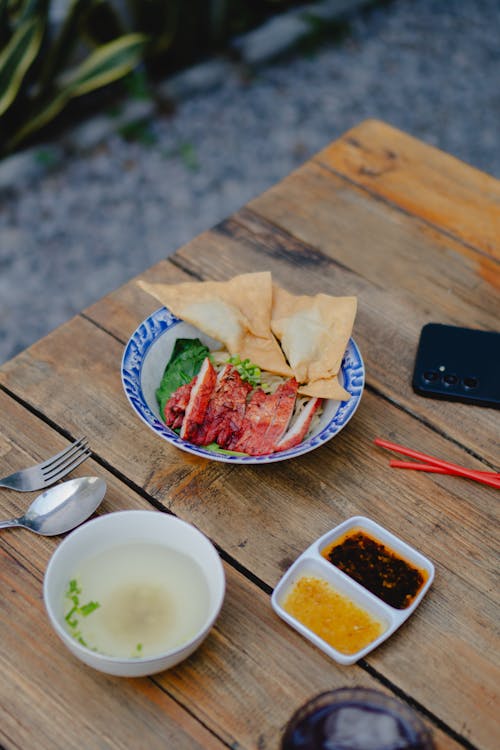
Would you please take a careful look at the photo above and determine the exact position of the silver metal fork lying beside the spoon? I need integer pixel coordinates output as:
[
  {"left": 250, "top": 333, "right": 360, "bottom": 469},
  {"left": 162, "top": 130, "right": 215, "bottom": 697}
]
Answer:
[{"left": 0, "top": 437, "right": 91, "bottom": 492}]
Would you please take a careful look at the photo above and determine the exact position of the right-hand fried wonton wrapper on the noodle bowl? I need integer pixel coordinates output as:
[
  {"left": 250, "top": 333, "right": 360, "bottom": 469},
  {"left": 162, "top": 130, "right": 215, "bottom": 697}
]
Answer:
[{"left": 271, "top": 286, "right": 357, "bottom": 384}]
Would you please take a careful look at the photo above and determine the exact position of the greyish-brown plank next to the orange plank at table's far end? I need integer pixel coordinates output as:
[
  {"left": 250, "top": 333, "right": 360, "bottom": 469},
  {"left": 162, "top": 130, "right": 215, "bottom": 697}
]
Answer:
[{"left": 248, "top": 162, "right": 500, "bottom": 304}]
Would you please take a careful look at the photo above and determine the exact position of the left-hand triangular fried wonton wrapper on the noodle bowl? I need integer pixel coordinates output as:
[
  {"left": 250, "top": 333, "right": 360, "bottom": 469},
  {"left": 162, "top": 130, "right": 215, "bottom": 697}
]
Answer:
[{"left": 139, "top": 271, "right": 292, "bottom": 376}]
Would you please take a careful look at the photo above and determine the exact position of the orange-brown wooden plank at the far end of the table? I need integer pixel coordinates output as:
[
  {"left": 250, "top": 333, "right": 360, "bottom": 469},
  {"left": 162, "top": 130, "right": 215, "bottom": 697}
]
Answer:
[{"left": 315, "top": 120, "right": 500, "bottom": 258}]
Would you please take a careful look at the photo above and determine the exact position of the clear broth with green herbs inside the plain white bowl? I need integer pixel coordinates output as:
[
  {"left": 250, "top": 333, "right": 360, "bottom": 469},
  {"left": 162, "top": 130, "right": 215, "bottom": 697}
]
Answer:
[{"left": 64, "top": 542, "right": 209, "bottom": 658}]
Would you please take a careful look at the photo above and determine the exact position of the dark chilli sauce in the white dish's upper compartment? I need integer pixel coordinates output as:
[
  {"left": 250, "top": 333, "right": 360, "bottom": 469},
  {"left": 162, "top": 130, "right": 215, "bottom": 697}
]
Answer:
[{"left": 321, "top": 530, "right": 427, "bottom": 609}]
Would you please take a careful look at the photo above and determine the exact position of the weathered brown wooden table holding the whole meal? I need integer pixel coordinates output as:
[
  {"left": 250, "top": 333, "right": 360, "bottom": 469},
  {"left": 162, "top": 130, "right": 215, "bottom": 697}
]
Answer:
[{"left": 0, "top": 121, "right": 500, "bottom": 750}]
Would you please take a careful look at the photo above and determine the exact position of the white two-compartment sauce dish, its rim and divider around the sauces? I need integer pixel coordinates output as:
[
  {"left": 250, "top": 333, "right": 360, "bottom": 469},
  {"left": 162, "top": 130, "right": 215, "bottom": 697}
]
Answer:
[{"left": 271, "top": 516, "right": 434, "bottom": 664}]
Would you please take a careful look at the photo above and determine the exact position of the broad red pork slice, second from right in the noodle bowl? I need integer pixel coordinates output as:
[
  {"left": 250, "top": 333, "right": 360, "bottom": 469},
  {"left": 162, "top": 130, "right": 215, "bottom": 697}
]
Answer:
[{"left": 230, "top": 378, "right": 298, "bottom": 456}]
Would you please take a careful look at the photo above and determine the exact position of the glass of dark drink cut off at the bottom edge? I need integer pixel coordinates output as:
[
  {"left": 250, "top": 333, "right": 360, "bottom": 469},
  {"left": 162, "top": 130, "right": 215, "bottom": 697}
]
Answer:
[{"left": 281, "top": 687, "right": 434, "bottom": 750}]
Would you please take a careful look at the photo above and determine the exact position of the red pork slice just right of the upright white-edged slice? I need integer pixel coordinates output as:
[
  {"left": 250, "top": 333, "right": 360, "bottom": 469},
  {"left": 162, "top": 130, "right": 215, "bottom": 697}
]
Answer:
[{"left": 199, "top": 365, "right": 252, "bottom": 448}]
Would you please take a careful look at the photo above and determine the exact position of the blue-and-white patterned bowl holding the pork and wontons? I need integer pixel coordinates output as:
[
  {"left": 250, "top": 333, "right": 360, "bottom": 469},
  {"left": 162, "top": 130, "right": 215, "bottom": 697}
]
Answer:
[{"left": 122, "top": 307, "right": 365, "bottom": 464}]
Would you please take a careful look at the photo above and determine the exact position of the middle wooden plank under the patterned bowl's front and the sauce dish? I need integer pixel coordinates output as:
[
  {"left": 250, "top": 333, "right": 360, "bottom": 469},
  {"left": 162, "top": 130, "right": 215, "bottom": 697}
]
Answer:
[{"left": 3, "top": 328, "right": 498, "bottom": 747}]
